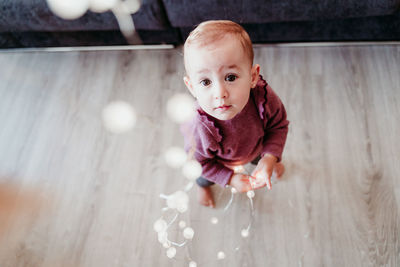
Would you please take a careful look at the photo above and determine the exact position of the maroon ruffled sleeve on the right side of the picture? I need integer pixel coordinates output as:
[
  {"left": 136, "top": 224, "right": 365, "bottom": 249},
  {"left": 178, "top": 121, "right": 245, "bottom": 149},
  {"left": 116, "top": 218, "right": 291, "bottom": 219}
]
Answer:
[{"left": 252, "top": 75, "right": 289, "bottom": 162}]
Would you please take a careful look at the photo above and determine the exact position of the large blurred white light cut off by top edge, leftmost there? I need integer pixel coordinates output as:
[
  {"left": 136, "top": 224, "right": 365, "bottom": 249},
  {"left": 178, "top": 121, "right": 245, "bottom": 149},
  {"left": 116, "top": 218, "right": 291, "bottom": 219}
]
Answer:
[{"left": 47, "top": 0, "right": 89, "bottom": 19}]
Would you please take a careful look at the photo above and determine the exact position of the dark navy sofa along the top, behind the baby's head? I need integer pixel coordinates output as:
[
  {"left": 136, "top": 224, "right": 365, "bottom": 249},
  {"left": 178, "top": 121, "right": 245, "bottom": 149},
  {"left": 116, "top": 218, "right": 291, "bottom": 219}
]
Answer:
[{"left": 0, "top": 0, "right": 400, "bottom": 48}]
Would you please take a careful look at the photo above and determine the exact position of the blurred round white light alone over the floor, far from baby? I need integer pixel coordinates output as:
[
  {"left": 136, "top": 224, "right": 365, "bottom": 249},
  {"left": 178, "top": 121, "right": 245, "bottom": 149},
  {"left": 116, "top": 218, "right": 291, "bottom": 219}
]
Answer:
[{"left": 103, "top": 101, "right": 136, "bottom": 133}]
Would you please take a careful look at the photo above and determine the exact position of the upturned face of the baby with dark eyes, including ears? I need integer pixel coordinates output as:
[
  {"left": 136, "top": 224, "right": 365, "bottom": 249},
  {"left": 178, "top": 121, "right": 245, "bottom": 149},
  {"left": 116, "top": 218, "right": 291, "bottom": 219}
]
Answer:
[{"left": 184, "top": 35, "right": 260, "bottom": 120}]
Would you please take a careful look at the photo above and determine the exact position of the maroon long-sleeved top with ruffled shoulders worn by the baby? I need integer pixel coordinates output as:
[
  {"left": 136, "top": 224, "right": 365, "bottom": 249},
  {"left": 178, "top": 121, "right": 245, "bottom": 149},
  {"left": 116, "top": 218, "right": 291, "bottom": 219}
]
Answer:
[{"left": 181, "top": 75, "right": 289, "bottom": 186}]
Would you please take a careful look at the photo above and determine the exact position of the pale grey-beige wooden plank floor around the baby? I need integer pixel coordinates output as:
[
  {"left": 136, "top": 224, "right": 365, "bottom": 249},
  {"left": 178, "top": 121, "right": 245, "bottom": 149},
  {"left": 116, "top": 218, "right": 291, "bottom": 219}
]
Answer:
[{"left": 0, "top": 46, "right": 400, "bottom": 267}]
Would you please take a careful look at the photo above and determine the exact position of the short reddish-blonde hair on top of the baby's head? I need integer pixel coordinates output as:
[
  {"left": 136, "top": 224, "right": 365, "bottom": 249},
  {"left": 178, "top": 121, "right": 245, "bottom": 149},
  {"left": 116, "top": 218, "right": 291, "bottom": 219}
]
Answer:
[{"left": 183, "top": 20, "right": 254, "bottom": 68}]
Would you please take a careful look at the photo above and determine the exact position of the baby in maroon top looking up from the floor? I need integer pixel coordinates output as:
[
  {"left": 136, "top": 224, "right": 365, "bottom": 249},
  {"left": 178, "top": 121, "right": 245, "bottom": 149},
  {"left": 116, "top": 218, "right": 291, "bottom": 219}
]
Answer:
[{"left": 181, "top": 20, "right": 289, "bottom": 207}]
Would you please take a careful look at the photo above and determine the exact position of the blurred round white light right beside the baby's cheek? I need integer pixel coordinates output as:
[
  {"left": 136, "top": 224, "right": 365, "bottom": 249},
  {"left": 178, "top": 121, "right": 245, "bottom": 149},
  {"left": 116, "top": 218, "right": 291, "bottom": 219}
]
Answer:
[{"left": 167, "top": 94, "right": 195, "bottom": 123}]
